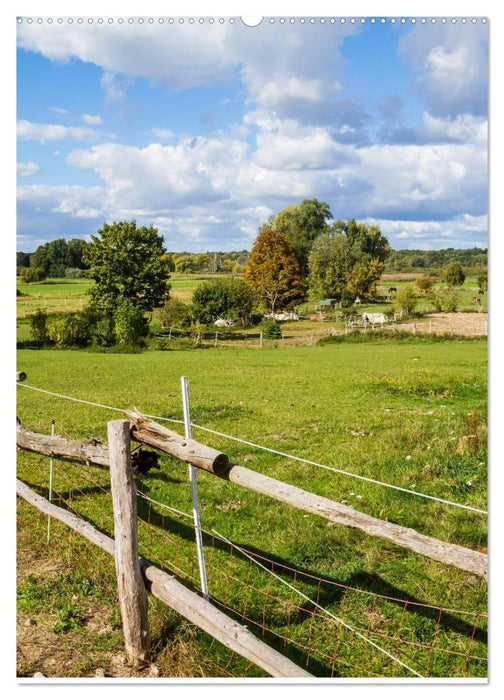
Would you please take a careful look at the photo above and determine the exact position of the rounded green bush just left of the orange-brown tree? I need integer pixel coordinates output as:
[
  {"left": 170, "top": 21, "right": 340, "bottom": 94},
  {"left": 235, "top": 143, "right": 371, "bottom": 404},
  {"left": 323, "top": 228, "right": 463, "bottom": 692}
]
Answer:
[{"left": 192, "top": 277, "right": 254, "bottom": 323}]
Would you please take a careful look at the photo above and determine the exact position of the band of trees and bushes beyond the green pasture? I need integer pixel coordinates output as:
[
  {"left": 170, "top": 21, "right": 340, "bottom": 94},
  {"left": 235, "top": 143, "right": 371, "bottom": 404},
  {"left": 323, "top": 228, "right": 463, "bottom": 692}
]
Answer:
[{"left": 21, "top": 205, "right": 486, "bottom": 346}]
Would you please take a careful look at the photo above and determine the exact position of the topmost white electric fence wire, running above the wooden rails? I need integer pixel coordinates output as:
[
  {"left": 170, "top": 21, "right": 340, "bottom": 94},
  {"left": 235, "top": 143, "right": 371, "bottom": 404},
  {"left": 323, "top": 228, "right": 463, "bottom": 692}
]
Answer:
[{"left": 16, "top": 382, "right": 488, "bottom": 515}]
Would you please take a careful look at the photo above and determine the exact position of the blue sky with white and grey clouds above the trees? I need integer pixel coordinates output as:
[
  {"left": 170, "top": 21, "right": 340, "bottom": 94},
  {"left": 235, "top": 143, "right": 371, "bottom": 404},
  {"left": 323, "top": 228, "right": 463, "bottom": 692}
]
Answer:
[{"left": 17, "top": 17, "right": 487, "bottom": 252}]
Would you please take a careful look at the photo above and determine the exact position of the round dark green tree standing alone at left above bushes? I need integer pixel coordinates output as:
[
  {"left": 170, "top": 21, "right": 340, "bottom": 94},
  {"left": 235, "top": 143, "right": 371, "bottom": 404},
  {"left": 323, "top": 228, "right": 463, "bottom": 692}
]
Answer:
[{"left": 85, "top": 221, "right": 170, "bottom": 311}]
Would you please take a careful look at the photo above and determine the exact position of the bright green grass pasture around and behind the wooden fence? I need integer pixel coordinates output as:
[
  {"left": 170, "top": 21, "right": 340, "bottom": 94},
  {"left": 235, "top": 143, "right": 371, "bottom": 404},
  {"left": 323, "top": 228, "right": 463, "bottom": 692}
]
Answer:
[{"left": 17, "top": 339, "right": 487, "bottom": 677}]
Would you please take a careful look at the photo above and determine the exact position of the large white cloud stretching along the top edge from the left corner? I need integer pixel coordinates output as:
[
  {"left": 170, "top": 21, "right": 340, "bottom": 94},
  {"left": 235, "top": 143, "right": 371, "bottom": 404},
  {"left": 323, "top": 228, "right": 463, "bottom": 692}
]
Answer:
[{"left": 18, "top": 22, "right": 360, "bottom": 123}]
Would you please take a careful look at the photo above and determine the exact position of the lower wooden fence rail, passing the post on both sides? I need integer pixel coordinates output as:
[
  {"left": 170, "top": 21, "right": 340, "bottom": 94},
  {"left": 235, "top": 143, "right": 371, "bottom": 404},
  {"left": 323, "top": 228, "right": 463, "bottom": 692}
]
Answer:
[{"left": 16, "top": 479, "right": 313, "bottom": 678}]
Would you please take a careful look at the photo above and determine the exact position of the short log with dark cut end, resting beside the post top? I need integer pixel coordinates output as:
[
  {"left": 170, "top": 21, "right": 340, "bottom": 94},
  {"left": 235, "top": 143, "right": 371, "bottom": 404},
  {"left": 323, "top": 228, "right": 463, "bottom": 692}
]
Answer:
[{"left": 124, "top": 411, "right": 230, "bottom": 477}]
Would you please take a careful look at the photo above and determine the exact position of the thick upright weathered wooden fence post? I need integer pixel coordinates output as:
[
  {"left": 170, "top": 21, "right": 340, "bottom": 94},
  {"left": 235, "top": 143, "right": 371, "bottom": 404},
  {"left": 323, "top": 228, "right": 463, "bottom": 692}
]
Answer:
[{"left": 107, "top": 420, "right": 150, "bottom": 665}]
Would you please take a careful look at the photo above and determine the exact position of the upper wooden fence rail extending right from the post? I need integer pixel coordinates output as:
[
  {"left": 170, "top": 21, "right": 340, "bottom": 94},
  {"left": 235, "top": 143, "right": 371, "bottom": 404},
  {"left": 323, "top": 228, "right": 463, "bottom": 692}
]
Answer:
[{"left": 125, "top": 411, "right": 488, "bottom": 577}]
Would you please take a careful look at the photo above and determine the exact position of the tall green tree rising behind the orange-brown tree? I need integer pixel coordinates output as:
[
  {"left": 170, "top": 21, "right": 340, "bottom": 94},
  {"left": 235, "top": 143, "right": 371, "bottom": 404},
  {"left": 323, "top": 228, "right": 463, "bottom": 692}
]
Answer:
[{"left": 272, "top": 199, "right": 332, "bottom": 274}]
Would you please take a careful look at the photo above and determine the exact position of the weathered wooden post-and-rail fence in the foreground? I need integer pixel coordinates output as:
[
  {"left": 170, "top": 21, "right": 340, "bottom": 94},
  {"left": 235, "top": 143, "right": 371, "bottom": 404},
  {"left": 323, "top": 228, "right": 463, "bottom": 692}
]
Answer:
[{"left": 16, "top": 373, "right": 487, "bottom": 677}]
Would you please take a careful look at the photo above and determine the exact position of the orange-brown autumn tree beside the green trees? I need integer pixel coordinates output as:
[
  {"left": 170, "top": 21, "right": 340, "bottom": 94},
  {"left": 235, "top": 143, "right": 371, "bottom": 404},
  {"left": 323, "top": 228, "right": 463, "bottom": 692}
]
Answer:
[{"left": 244, "top": 225, "right": 306, "bottom": 314}]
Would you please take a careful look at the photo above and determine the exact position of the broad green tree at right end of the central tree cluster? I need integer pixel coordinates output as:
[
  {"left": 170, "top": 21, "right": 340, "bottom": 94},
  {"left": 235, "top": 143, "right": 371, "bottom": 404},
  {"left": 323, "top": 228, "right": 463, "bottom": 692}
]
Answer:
[{"left": 309, "top": 219, "right": 390, "bottom": 301}]
